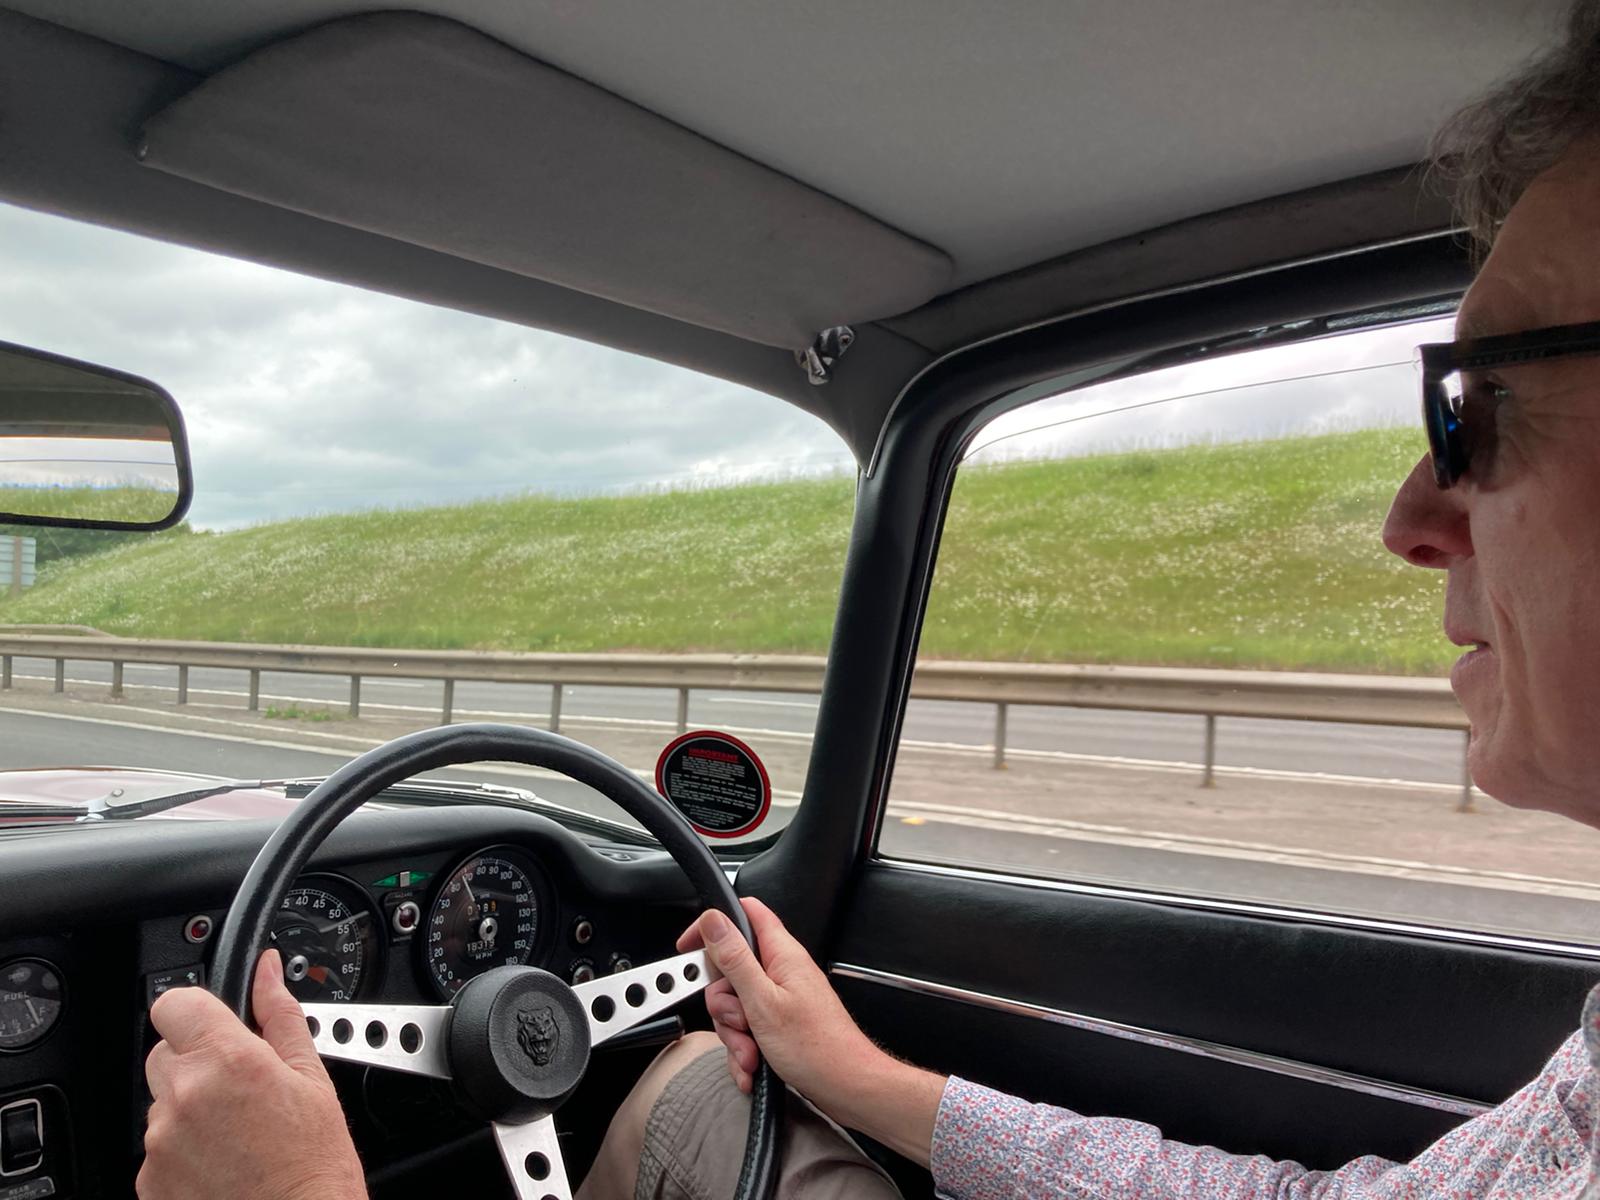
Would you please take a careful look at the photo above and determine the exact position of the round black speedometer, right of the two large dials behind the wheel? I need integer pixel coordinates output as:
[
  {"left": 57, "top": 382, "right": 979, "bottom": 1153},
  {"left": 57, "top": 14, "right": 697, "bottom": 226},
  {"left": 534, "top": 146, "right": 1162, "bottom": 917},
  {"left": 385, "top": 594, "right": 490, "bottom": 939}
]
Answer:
[{"left": 424, "top": 850, "right": 539, "bottom": 1000}]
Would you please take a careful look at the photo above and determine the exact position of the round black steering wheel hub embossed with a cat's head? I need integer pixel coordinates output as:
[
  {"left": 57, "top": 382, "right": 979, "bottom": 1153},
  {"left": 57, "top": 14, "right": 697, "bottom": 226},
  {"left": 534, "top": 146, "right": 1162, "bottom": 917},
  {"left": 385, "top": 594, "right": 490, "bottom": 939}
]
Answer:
[{"left": 450, "top": 966, "right": 589, "bottom": 1122}]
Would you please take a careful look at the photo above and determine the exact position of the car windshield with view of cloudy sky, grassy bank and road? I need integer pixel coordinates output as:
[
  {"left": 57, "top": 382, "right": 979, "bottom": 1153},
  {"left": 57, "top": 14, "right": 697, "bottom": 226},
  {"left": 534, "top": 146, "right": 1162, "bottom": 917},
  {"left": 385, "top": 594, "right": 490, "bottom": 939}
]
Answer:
[{"left": 0, "top": 206, "right": 854, "bottom": 843}]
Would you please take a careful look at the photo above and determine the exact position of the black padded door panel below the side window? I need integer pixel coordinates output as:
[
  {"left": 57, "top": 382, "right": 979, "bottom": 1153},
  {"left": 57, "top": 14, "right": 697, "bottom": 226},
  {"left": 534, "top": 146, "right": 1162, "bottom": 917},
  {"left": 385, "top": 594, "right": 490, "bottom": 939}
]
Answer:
[{"left": 834, "top": 864, "right": 1600, "bottom": 1168}]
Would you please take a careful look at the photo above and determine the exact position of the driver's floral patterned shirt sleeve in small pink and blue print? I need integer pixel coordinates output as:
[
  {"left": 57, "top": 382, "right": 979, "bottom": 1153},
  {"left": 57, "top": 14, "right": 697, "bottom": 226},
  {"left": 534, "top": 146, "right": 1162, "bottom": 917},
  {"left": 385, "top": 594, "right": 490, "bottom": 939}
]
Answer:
[{"left": 933, "top": 987, "right": 1600, "bottom": 1200}]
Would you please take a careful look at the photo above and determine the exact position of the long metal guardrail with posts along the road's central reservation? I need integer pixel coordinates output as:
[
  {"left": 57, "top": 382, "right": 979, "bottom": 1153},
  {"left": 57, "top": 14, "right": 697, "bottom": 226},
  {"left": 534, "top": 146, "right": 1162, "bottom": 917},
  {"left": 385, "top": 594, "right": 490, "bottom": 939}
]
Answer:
[{"left": 0, "top": 632, "right": 1472, "bottom": 808}]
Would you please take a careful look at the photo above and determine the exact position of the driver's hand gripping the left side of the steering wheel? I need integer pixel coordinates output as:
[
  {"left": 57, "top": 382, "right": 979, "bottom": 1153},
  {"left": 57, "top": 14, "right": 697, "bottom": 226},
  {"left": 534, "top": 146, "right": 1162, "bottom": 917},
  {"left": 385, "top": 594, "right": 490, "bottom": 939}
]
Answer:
[{"left": 136, "top": 950, "right": 366, "bottom": 1200}]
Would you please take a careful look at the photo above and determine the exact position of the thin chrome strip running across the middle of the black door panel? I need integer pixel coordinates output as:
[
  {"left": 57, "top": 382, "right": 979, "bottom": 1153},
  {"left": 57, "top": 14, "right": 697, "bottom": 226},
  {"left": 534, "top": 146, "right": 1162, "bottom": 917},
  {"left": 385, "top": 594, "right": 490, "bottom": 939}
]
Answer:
[{"left": 829, "top": 963, "right": 1493, "bottom": 1117}]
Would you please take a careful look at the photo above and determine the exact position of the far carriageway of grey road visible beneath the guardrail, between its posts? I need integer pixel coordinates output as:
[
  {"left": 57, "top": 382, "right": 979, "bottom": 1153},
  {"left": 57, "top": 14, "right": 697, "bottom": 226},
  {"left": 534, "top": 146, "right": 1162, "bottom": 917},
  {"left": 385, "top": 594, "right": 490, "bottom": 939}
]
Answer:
[{"left": 3, "top": 659, "right": 1462, "bottom": 786}]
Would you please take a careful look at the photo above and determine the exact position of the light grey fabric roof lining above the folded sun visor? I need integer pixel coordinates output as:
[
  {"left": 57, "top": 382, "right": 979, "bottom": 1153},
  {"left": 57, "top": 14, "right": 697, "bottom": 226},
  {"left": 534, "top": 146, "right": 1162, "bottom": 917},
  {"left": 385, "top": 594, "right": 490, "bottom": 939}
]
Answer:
[{"left": 3, "top": 0, "right": 1562, "bottom": 285}]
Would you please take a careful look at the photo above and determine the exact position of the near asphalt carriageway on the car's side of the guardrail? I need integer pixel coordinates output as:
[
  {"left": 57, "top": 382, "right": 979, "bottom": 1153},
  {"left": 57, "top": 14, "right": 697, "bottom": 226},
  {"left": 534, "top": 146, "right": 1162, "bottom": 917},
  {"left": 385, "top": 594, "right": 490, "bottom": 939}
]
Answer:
[{"left": 0, "top": 710, "right": 1600, "bottom": 941}]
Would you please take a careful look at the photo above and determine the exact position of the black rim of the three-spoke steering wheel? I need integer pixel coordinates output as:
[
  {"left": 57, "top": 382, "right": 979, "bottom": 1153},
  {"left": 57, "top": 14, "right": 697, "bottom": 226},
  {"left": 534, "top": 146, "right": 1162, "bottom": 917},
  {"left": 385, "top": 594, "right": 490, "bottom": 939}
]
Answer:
[{"left": 211, "top": 723, "right": 784, "bottom": 1200}]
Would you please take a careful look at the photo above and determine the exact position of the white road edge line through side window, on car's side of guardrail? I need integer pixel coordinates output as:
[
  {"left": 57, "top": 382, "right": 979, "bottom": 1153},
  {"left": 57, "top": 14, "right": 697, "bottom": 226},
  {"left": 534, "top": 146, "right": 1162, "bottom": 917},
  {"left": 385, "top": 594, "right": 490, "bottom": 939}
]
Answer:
[{"left": 888, "top": 800, "right": 1600, "bottom": 901}]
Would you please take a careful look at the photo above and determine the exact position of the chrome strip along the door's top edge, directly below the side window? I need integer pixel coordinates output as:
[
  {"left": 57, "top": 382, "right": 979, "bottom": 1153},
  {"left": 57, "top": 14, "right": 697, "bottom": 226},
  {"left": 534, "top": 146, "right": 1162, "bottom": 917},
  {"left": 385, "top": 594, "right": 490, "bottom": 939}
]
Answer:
[{"left": 867, "top": 858, "right": 1600, "bottom": 963}]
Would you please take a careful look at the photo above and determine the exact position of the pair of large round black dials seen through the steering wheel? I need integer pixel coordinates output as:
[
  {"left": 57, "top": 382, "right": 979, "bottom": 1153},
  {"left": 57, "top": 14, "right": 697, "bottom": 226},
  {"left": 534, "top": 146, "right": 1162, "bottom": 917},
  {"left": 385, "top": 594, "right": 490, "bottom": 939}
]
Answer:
[{"left": 272, "top": 846, "right": 554, "bottom": 1002}]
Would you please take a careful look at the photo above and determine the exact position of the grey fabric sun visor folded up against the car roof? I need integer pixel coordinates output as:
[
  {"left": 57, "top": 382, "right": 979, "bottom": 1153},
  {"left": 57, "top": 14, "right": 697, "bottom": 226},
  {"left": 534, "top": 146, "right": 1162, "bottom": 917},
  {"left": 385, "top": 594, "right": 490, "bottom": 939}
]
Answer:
[{"left": 142, "top": 13, "right": 950, "bottom": 350}]
